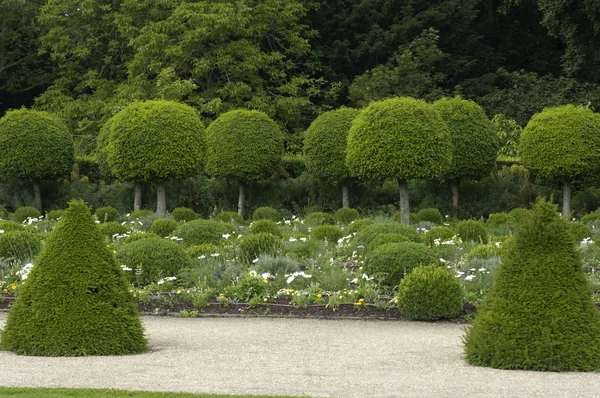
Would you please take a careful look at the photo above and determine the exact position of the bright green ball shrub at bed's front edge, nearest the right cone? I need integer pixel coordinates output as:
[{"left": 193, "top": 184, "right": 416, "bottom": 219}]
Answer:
[{"left": 396, "top": 265, "right": 463, "bottom": 321}]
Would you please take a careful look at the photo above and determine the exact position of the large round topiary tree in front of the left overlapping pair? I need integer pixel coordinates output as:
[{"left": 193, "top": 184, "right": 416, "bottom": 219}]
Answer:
[{"left": 105, "top": 101, "right": 205, "bottom": 216}]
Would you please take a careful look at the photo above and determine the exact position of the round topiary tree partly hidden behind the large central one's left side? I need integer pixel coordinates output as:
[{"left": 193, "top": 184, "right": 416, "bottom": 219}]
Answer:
[{"left": 304, "top": 108, "right": 359, "bottom": 208}]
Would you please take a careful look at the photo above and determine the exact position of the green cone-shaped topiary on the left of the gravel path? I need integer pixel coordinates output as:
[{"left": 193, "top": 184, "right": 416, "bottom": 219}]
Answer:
[{"left": 0, "top": 201, "right": 147, "bottom": 356}]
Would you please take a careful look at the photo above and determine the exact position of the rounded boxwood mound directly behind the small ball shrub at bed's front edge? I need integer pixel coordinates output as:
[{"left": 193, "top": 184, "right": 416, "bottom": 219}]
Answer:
[{"left": 363, "top": 239, "right": 439, "bottom": 287}]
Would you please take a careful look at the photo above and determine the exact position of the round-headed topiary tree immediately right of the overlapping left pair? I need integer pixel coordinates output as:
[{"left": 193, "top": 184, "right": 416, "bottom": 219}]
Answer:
[{"left": 206, "top": 109, "right": 283, "bottom": 215}]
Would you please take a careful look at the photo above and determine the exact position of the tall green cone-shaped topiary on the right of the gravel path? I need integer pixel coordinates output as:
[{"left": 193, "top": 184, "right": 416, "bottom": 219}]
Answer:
[{"left": 465, "top": 201, "right": 600, "bottom": 371}]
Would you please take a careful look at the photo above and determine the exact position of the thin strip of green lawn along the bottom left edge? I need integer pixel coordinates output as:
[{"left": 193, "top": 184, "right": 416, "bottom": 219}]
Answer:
[{"left": 0, "top": 387, "right": 302, "bottom": 398}]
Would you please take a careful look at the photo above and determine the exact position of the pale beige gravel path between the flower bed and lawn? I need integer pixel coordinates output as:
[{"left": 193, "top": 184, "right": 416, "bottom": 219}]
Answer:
[{"left": 0, "top": 313, "right": 600, "bottom": 398}]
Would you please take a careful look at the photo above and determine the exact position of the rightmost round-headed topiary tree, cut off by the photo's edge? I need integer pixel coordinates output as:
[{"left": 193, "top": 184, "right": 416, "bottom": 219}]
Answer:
[{"left": 519, "top": 105, "right": 600, "bottom": 220}]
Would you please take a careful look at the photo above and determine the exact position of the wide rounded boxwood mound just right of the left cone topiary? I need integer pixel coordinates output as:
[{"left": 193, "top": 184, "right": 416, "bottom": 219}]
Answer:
[{"left": 117, "top": 238, "right": 190, "bottom": 286}]
